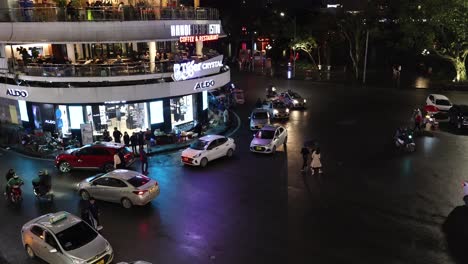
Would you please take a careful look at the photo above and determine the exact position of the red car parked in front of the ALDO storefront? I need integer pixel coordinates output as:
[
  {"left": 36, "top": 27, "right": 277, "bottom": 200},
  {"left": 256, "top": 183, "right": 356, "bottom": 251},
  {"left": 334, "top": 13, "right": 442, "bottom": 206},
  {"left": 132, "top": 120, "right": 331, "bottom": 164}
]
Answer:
[{"left": 55, "top": 142, "right": 135, "bottom": 172}]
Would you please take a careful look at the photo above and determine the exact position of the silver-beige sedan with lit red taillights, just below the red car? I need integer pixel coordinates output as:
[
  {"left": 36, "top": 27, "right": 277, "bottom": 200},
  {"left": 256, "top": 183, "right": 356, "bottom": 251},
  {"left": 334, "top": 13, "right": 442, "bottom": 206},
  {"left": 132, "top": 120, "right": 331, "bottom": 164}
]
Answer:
[{"left": 78, "top": 170, "right": 160, "bottom": 208}]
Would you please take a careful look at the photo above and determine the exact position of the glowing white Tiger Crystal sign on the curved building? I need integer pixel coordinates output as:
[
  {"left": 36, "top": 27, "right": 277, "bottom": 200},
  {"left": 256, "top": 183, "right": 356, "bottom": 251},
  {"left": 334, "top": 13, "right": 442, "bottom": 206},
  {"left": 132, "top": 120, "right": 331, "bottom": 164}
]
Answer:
[{"left": 172, "top": 55, "right": 223, "bottom": 81}]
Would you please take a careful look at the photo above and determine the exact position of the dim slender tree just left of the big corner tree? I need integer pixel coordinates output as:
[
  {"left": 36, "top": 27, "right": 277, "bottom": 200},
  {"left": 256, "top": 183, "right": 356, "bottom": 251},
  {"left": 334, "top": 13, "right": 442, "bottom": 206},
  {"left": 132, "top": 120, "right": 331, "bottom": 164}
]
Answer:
[{"left": 338, "top": 13, "right": 368, "bottom": 79}]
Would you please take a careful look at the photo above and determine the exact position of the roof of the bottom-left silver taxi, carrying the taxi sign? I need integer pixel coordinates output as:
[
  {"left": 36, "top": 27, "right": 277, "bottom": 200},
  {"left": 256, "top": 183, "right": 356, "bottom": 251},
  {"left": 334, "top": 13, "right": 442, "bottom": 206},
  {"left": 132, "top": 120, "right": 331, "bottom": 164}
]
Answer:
[{"left": 31, "top": 211, "right": 82, "bottom": 234}]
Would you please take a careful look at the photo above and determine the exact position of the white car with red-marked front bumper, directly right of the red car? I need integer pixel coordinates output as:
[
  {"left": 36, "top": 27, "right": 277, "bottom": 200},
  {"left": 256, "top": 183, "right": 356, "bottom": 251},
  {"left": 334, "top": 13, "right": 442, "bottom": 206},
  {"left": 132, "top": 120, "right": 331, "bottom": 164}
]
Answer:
[{"left": 180, "top": 135, "right": 236, "bottom": 167}]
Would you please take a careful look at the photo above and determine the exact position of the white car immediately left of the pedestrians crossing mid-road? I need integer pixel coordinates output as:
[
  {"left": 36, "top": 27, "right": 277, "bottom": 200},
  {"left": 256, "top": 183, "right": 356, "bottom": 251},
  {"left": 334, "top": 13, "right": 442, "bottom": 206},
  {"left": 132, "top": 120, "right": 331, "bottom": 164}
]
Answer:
[{"left": 250, "top": 125, "right": 288, "bottom": 154}]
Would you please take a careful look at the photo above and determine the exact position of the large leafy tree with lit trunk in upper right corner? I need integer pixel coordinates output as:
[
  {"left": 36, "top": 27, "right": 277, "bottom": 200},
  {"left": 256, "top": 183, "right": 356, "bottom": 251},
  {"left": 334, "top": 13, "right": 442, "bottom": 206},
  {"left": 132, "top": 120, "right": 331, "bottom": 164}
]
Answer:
[{"left": 401, "top": 0, "right": 468, "bottom": 81}]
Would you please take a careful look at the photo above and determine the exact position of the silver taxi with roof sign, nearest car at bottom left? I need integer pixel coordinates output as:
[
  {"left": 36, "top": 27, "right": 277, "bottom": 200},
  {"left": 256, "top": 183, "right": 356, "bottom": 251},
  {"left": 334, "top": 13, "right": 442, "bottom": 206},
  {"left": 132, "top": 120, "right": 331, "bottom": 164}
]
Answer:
[{"left": 21, "top": 211, "right": 114, "bottom": 264}]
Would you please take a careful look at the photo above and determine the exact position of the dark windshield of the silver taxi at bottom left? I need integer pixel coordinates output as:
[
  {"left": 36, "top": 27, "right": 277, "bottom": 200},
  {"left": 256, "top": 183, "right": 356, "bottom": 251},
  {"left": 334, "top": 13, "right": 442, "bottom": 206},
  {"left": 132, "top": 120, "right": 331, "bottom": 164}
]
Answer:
[{"left": 55, "top": 221, "right": 98, "bottom": 251}]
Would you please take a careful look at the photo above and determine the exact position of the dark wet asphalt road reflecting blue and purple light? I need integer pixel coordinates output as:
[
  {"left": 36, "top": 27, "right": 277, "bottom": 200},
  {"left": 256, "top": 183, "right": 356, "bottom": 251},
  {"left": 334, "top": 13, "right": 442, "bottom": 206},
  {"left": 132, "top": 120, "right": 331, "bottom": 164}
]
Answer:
[{"left": 0, "top": 71, "right": 468, "bottom": 264}]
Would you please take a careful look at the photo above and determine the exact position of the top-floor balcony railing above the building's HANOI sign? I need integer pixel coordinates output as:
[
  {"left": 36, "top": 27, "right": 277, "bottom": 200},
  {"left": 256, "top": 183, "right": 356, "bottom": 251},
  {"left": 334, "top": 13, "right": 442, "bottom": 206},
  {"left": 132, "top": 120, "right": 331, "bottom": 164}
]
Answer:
[{"left": 0, "top": 6, "right": 219, "bottom": 22}]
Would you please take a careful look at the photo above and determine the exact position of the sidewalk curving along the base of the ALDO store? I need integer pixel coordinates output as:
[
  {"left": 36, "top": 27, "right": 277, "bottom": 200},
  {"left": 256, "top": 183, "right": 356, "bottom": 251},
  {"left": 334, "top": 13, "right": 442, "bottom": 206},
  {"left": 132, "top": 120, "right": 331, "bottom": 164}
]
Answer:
[{"left": 1, "top": 111, "right": 239, "bottom": 160}]
